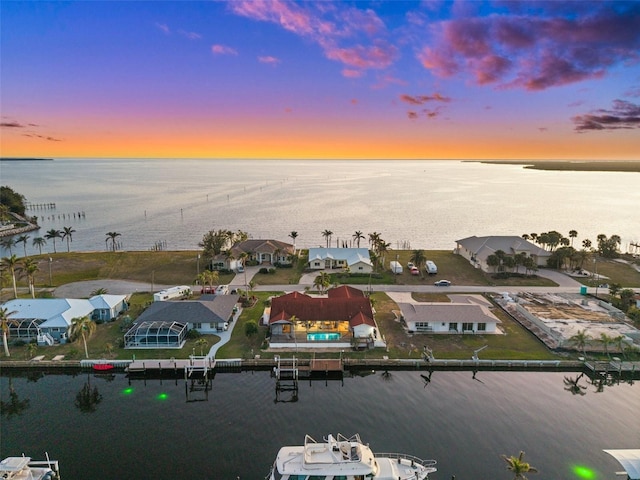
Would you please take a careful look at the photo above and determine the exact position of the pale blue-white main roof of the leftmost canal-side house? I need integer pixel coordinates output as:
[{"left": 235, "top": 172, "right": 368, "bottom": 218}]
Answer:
[{"left": 4, "top": 298, "right": 95, "bottom": 328}]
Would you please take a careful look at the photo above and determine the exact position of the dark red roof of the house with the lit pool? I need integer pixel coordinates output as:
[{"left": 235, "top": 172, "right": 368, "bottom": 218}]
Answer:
[{"left": 269, "top": 287, "right": 375, "bottom": 326}]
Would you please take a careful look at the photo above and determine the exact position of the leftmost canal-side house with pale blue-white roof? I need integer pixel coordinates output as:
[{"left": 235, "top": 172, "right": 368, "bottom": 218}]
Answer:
[{"left": 3, "top": 295, "right": 126, "bottom": 345}]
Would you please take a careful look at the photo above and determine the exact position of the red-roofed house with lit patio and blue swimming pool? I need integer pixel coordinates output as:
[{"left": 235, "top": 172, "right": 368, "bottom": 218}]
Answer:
[{"left": 269, "top": 286, "right": 378, "bottom": 344}]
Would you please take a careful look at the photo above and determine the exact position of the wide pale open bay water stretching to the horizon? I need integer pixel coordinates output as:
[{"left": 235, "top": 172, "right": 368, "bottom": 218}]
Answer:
[{"left": 0, "top": 159, "right": 640, "bottom": 255}]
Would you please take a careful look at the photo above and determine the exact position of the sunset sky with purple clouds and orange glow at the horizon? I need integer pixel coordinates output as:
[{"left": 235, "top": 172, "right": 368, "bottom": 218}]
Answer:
[{"left": 0, "top": 0, "right": 640, "bottom": 160}]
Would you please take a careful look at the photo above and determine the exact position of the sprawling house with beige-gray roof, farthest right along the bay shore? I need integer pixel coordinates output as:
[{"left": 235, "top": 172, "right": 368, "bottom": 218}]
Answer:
[{"left": 455, "top": 235, "right": 551, "bottom": 272}]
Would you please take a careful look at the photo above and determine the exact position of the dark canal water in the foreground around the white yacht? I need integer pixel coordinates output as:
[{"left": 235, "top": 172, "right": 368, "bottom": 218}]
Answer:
[{"left": 0, "top": 371, "right": 640, "bottom": 480}]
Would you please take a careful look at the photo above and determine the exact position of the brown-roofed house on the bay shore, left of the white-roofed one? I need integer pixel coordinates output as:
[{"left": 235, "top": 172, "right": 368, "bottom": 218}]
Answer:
[{"left": 211, "top": 240, "right": 295, "bottom": 270}]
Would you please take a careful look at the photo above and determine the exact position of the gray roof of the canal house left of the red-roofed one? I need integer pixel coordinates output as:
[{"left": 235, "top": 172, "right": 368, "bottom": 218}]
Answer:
[{"left": 136, "top": 295, "right": 239, "bottom": 323}]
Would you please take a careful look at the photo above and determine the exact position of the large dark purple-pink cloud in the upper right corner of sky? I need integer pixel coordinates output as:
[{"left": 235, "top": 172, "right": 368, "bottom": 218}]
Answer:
[{"left": 418, "top": 2, "right": 640, "bottom": 91}]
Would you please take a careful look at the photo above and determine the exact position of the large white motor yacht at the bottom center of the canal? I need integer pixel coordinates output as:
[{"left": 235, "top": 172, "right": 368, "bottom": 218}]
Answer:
[{"left": 267, "top": 433, "right": 437, "bottom": 480}]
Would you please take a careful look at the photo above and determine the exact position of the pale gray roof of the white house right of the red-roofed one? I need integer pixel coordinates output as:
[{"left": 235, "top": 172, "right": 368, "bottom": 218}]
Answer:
[{"left": 398, "top": 303, "right": 500, "bottom": 323}]
